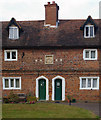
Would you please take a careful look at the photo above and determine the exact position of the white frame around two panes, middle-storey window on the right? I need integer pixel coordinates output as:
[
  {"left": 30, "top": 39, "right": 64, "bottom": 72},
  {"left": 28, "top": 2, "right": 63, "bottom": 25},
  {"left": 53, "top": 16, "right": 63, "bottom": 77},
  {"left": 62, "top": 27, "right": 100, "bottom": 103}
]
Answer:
[{"left": 83, "top": 49, "right": 98, "bottom": 60}]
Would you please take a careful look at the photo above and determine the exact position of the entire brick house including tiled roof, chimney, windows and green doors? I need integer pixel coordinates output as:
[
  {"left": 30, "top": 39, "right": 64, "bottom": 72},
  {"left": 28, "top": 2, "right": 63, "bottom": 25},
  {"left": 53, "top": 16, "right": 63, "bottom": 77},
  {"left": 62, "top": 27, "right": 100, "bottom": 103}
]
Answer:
[{"left": 2, "top": 2, "right": 101, "bottom": 102}]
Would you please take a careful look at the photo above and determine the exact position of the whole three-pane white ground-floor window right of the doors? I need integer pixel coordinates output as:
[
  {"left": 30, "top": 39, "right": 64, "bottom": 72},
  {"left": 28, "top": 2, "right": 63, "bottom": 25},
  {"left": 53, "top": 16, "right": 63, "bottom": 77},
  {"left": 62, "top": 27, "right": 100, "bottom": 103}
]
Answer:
[{"left": 80, "top": 77, "right": 99, "bottom": 90}]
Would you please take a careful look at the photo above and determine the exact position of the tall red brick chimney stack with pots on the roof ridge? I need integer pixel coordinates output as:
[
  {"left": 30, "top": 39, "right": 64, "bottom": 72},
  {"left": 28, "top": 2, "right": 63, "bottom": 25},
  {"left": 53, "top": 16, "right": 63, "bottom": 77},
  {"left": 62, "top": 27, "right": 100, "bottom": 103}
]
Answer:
[{"left": 45, "top": 1, "right": 59, "bottom": 27}]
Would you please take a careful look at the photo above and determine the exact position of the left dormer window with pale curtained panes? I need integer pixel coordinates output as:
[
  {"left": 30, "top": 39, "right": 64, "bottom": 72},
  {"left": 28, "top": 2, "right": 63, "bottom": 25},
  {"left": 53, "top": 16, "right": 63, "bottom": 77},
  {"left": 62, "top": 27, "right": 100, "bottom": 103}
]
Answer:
[{"left": 9, "top": 26, "right": 19, "bottom": 39}]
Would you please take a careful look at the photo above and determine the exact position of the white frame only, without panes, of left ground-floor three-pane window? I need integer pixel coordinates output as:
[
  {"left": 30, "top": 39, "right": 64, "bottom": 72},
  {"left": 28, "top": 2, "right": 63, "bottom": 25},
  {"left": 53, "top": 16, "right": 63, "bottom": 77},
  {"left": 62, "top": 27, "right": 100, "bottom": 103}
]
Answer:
[{"left": 2, "top": 77, "right": 21, "bottom": 90}]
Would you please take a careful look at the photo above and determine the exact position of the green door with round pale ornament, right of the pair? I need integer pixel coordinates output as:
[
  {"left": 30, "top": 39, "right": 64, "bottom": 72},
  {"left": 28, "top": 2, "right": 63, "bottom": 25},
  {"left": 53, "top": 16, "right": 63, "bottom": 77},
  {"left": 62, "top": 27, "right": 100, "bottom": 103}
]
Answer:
[{"left": 55, "top": 79, "right": 62, "bottom": 100}]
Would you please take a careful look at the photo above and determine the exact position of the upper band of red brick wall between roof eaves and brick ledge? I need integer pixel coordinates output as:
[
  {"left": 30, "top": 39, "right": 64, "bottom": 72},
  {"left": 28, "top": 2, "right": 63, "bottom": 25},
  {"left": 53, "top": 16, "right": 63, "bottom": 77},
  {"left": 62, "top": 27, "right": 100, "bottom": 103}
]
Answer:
[{"left": 3, "top": 49, "right": 99, "bottom": 71}]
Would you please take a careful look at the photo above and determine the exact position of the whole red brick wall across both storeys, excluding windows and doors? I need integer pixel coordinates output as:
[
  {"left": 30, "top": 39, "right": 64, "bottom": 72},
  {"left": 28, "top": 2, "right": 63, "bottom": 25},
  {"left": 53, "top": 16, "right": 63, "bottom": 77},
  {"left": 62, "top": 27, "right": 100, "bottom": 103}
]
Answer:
[{"left": 3, "top": 49, "right": 101, "bottom": 102}]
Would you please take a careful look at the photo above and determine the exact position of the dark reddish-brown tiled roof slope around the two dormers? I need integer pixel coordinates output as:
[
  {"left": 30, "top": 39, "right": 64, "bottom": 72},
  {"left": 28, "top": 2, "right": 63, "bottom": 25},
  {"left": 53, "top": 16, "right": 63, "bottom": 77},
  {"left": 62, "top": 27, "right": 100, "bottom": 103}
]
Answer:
[{"left": 2, "top": 19, "right": 100, "bottom": 48}]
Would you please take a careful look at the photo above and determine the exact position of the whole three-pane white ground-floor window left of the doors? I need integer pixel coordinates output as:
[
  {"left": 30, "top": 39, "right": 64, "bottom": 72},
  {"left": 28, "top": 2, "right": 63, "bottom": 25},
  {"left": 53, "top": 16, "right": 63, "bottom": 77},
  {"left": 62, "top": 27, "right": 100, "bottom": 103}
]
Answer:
[{"left": 3, "top": 77, "right": 21, "bottom": 89}]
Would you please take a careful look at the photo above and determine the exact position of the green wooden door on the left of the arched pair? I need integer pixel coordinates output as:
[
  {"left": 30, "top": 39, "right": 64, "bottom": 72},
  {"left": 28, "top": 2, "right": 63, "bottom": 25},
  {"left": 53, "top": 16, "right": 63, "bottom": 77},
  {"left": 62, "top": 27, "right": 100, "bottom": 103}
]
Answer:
[{"left": 39, "top": 79, "right": 46, "bottom": 100}]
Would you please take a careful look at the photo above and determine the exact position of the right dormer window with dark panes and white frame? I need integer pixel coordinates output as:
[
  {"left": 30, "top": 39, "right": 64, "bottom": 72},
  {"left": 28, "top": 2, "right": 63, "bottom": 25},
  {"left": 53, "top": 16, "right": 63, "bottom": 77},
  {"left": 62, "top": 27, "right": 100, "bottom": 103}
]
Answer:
[{"left": 84, "top": 25, "right": 95, "bottom": 38}]
